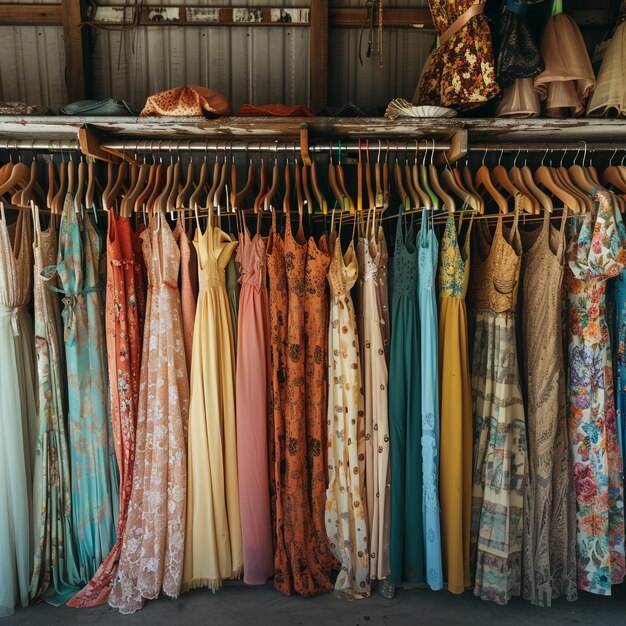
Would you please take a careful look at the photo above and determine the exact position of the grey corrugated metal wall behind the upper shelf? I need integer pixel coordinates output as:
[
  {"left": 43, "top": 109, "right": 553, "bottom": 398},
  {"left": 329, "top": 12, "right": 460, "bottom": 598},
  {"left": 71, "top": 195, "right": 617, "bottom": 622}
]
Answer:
[{"left": 0, "top": 0, "right": 434, "bottom": 110}]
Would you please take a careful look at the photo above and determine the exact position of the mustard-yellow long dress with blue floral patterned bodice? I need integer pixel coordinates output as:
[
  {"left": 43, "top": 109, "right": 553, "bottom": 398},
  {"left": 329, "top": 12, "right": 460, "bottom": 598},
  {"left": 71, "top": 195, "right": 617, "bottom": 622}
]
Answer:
[{"left": 439, "top": 213, "right": 473, "bottom": 593}]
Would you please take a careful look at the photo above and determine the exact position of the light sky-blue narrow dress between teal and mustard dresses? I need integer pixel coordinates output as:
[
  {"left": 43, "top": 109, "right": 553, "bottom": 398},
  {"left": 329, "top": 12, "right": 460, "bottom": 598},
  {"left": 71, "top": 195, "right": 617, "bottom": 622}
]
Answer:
[{"left": 417, "top": 209, "right": 443, "bottom": 590}]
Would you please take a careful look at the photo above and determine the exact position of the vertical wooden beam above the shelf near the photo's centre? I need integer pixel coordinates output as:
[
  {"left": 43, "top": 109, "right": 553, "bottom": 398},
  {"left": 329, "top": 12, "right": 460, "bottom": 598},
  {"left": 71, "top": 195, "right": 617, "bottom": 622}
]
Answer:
[{"left": 309, "top": 0, "right": 328, "bottom": 113}]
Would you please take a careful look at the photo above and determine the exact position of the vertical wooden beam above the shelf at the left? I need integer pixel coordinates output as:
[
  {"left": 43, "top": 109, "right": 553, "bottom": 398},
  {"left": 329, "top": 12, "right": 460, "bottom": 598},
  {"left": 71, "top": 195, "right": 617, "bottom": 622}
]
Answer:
[{"left": 61, "top": 0, "right": 87, "bottom": 102}]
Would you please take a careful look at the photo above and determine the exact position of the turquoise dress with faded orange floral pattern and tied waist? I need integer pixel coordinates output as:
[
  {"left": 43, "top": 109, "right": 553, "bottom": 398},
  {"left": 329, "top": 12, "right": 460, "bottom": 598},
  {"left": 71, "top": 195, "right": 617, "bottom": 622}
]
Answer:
[{"left": 45, "top": 194, "right": 118, "bottom": 585}]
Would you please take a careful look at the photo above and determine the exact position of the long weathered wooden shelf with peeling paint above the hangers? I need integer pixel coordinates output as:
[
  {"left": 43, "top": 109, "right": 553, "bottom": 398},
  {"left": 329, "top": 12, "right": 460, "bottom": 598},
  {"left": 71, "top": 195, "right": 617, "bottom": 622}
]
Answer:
[{"left": 0, "top": 116, "right": 626, "bottom": 144}]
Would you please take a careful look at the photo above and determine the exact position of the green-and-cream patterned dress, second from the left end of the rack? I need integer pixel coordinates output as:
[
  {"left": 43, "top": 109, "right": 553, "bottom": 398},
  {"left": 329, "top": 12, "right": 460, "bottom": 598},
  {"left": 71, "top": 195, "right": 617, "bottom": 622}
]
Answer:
[{"left": 30, "top": 207, "right": 80, "bottom": 605}]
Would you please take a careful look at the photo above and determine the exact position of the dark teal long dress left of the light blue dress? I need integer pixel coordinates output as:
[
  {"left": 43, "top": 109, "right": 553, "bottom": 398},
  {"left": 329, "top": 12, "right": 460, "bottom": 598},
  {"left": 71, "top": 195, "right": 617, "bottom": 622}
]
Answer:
[{"left": 387, "top": 208, "right": 424, "bottom": 584}]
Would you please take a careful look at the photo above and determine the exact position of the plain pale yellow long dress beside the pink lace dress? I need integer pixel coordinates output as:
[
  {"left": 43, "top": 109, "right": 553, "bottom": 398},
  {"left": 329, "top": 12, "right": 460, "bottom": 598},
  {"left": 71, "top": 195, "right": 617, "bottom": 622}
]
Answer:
[{"left": 183, "top": 215, "right": 243, "bottom": 591}]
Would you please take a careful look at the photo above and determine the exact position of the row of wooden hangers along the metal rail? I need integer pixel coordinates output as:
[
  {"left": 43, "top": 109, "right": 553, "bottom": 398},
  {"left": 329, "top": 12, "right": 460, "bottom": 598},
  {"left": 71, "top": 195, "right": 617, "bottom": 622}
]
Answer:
[{"left": 0, "top": 140, "right": 626, "bottom": 220}]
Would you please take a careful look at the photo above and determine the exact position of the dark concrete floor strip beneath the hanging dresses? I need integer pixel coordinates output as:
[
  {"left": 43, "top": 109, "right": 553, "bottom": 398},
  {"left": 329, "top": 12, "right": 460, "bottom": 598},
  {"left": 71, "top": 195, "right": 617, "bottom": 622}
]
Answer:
[{"left": 0, "top": 584, "right": 626, "bottom": 626}]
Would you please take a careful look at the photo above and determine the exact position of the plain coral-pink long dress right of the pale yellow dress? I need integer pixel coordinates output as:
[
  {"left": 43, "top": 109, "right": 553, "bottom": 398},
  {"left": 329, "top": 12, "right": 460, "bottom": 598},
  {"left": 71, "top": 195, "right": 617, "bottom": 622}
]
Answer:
[{"left": 235, "top": 218, "right": 274, "bottom": 585}]
